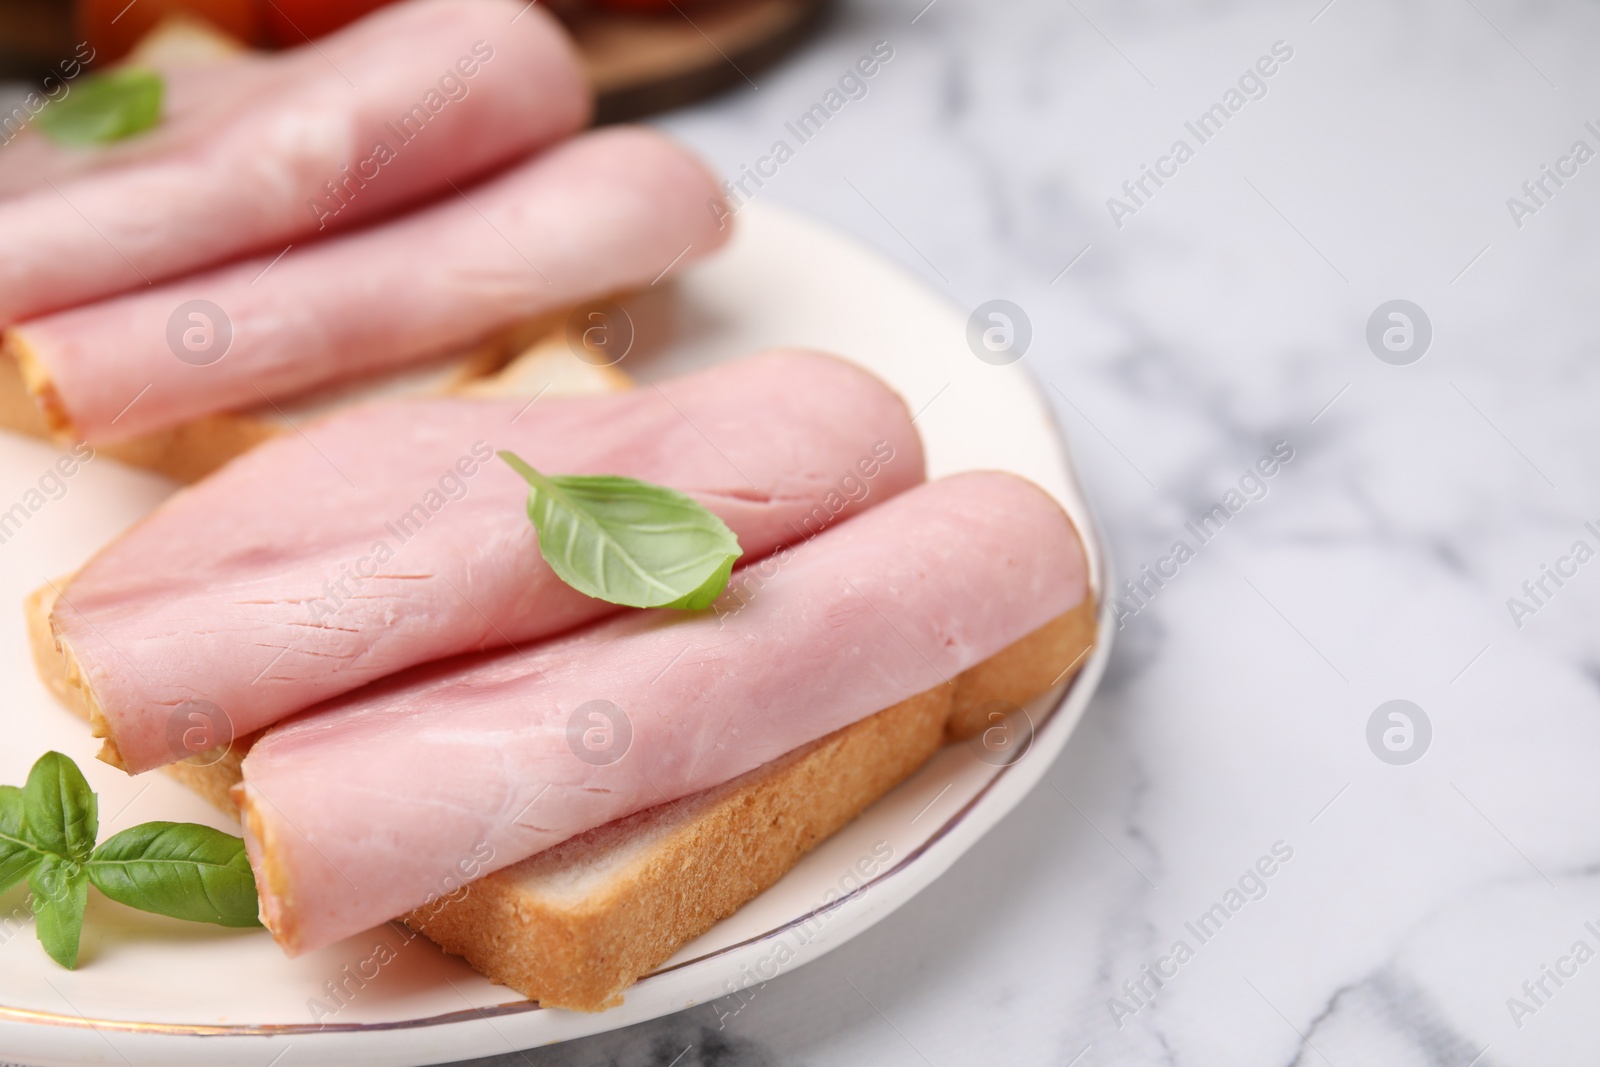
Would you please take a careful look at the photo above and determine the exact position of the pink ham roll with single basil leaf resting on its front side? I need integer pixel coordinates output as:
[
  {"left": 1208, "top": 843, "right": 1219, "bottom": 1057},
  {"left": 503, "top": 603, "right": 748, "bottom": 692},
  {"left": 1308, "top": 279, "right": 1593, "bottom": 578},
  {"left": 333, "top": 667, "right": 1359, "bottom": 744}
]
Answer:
[{"left": 53, "top": 352, "right": 923, "bottom": 771}]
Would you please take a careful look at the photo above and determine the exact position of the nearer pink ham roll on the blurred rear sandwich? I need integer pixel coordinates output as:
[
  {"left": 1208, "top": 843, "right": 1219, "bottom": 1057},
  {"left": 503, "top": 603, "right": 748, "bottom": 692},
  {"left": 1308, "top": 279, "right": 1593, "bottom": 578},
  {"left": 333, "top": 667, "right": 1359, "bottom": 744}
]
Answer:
[{"left": 10, "top": 126, "right": 725, "bottom": 443}]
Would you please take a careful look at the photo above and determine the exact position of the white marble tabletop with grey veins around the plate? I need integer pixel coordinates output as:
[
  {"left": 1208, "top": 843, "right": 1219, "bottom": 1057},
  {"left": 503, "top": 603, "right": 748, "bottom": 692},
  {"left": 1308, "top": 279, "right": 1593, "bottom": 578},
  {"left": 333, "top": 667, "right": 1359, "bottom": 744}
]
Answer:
[{"left": 454, "top": 0, "right": 1600, "bottom": 1067}]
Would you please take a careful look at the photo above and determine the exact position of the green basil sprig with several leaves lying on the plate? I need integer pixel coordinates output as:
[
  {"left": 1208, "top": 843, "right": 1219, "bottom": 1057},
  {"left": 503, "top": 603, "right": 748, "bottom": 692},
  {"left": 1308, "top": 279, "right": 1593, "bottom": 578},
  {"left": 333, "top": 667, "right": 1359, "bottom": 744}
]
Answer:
[{"left": 0, "top": 752, "right": 261, "bottom": 969}]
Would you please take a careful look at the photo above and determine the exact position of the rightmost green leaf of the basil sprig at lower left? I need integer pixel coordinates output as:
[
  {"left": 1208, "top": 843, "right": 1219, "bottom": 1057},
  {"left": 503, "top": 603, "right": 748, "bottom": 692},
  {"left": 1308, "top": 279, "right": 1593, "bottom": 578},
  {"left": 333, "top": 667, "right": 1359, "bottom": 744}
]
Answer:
[{"left": 88, "top": 822, "right": 261, "bottom": 926}]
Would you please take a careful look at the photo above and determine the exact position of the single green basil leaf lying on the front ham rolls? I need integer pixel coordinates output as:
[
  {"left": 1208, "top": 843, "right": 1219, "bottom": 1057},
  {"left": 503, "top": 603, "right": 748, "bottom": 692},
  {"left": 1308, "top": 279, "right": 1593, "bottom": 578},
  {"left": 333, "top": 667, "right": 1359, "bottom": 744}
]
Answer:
[{"left": 499, "top": 453, "right": 741, "bottom": 609}]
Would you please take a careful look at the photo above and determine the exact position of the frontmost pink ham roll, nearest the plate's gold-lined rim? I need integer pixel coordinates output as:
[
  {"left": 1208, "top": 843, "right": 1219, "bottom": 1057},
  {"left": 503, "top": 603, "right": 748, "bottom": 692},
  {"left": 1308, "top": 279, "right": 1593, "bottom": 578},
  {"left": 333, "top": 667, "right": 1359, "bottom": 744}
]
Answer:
[{"left": 234, "top": 472, "right": 1088, "bottom": 955}]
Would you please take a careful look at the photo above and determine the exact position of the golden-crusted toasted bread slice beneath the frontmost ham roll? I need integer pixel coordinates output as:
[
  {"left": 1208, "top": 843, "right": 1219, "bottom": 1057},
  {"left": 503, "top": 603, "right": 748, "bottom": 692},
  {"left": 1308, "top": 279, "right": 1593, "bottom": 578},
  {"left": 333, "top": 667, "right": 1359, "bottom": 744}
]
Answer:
[{"left": 405, "top": 598, "right": 1094, "bottom": 1011}]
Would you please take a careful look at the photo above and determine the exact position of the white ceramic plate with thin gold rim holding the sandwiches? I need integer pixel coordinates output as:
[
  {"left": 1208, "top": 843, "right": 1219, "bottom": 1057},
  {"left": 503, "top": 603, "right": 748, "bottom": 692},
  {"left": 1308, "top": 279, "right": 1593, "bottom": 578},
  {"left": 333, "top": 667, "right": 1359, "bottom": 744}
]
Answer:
[{"left": 0, "top": 205, "right": 1110, "bottom": 1067}]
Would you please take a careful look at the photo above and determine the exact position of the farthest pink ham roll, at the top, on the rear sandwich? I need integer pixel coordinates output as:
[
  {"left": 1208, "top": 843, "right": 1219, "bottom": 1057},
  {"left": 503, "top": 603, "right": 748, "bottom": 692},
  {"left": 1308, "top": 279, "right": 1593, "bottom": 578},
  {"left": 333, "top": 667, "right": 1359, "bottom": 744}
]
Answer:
[{"left": 0, "top": 0, "right": 590, "bottom": 325}]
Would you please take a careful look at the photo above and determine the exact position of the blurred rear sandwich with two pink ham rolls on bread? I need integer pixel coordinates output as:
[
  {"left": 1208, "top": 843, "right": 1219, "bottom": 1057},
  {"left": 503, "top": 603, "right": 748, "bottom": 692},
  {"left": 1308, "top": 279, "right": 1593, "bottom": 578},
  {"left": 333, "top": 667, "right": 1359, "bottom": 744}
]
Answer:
[{"left": 0, "top": 0, "right": 726, "bottom": 482}]
